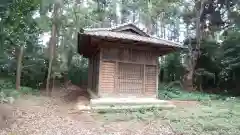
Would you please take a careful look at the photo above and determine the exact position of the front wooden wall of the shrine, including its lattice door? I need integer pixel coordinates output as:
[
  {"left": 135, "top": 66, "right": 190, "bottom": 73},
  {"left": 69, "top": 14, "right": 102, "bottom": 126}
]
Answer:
[{"left": 99, "top": 48, "right": 158, "bottom": 97}]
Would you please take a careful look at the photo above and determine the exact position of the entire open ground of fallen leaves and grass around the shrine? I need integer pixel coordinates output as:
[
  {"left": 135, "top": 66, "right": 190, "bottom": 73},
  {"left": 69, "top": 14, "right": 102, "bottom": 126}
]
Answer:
[{"left": 0, "top": 88, "right": 240, "bottom": 135}]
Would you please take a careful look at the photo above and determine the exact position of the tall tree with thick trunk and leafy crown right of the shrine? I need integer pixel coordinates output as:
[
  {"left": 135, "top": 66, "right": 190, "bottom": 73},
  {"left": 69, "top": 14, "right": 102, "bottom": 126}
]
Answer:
[{"left": 184, "top": 0, "right": 237, "bottom": 90}]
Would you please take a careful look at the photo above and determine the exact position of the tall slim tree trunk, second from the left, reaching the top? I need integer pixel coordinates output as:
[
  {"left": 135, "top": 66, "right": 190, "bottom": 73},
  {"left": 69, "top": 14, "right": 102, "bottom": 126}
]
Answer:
[{"left": 46, "top": 3, "right": 59, "bottom": 96}]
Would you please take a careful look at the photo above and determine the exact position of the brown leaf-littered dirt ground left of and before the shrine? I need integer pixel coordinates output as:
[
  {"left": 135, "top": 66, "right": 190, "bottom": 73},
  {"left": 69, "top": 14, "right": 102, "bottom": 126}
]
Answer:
[{"left": 0, "top": 87, "right": 178, "bottom": 135}]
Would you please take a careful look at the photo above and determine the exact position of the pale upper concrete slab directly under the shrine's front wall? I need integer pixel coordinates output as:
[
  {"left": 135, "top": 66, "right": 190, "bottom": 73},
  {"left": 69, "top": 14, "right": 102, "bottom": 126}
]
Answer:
[{"left": 90, "top": 98, "right": 170, "bottom": 107}]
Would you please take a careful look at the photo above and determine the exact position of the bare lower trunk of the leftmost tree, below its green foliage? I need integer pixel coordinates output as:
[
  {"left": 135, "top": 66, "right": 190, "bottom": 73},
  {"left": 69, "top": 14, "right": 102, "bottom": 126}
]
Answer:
[{"left": 16, "top": 45, "right": 24, "bottom": 90}]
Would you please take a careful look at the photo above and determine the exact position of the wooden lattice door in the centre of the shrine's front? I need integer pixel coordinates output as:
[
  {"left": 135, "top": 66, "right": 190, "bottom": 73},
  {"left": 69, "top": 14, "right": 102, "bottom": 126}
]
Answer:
[{"left": 116, "top": 62, "right": 144, "bottom": 95}]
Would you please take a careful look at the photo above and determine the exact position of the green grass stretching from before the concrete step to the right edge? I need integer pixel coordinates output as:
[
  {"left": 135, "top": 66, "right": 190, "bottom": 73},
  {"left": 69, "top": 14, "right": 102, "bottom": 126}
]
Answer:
[{"left": 93, "top": 98, "right": 240, "bottom": 135}]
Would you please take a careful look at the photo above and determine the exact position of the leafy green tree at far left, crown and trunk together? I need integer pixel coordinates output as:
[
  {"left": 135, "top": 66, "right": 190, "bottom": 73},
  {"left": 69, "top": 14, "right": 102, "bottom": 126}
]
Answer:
[{"left": 0, "top": 0, "right": 39, "bottom": 89}]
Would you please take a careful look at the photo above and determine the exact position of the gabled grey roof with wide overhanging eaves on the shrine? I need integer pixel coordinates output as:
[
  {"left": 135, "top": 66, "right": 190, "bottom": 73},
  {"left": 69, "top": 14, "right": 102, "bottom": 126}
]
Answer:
[{"left": 78, "top": 23, "right": 184, "bottom": 55}]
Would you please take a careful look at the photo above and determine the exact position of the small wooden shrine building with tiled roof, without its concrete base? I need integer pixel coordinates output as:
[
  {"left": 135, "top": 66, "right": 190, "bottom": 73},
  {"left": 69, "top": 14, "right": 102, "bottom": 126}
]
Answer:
[{"left": 78, "top": 24, "right": 181, "bottom": 98}]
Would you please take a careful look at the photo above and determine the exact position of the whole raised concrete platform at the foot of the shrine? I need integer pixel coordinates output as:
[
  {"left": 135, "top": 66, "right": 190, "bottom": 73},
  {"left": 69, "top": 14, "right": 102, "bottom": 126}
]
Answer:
[{"left": 77, "top": 98, "right": 175, "bottom": 112}]
